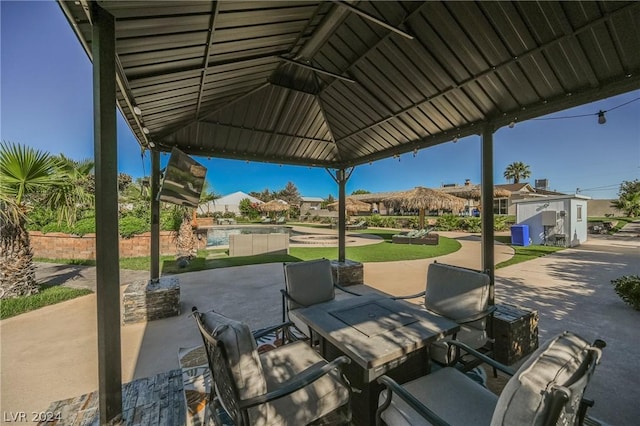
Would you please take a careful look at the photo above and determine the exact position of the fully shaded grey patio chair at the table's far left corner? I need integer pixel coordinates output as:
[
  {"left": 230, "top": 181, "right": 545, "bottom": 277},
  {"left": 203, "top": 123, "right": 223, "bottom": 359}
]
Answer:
[{"left": 280, "top": 259, "right": 360, "bottom": 338}]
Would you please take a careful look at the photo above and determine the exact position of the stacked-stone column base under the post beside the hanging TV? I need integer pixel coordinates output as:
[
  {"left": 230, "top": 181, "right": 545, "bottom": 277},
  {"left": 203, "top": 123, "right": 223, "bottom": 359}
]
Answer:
[{"left": 122, "top": 277, "right": 180, "bottom": 324}]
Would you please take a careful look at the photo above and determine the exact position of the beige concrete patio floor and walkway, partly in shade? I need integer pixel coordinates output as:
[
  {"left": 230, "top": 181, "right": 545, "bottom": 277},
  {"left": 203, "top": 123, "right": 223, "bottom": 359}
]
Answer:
[{"left": 0, "top": 223, "right": 640, "bottom": 425}]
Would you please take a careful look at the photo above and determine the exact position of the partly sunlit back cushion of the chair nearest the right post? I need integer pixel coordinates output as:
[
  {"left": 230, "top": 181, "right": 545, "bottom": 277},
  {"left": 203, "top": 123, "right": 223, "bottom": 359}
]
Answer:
[{"left": 425, "top": 263, "right": 490, "bottom": 320}]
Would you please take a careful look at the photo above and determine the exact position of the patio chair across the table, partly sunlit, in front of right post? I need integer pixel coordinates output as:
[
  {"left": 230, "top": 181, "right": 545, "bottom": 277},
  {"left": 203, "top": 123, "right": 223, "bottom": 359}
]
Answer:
[{"left": 394, "top": 262, "right": 496, "bottom": 365}]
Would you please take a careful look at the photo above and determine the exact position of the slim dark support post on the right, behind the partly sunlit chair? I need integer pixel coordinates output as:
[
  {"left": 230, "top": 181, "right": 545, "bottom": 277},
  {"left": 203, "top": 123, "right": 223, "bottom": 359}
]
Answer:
[{"left": 480, "top": 125, "right": 495, "bottom": 305}]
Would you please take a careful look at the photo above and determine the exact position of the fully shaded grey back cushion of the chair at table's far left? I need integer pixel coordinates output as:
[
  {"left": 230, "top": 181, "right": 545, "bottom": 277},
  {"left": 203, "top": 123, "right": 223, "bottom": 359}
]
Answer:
[{"left": 284, "top": 259, "right": 335, "bottom": 310}]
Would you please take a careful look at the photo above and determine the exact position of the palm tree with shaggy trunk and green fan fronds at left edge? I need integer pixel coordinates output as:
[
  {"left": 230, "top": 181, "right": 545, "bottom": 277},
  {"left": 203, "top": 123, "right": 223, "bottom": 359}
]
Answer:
[{"left": 0, "top": 141, "right": 59, "bottom": 299}]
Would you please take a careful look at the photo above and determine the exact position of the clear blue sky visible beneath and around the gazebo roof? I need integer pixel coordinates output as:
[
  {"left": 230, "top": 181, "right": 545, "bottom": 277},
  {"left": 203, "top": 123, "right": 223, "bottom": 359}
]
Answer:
[{"left": 0, "top": 0, "right": 640, "bottom": 198}]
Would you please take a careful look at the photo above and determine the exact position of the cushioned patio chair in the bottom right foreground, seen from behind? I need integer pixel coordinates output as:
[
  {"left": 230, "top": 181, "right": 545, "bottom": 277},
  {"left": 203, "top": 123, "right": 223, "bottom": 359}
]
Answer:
[{"left": 376, "top": 332, "right": 606, "bottom": 426}]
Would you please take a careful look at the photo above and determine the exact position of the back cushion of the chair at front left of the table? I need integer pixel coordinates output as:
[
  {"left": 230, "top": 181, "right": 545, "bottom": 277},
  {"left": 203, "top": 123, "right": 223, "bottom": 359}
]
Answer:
[{"left": 201, "top": 312, "right": 267, "bottom": 399}]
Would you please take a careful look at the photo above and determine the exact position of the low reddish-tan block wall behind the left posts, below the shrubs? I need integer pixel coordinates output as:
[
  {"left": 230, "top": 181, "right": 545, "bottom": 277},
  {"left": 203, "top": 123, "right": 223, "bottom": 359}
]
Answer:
[{"left": 29, "top": 231, "right": 206, "bottom": 259}]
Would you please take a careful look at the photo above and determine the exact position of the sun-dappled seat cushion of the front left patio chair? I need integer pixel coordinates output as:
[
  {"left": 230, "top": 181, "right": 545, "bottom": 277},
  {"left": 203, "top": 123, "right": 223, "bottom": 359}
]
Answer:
[{"left": 249, "top": 342, "right": 349, "bottom": 426}]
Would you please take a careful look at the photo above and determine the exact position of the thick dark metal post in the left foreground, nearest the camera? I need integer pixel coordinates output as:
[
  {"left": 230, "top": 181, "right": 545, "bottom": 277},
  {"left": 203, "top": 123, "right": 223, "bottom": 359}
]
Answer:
[{"left": 91, "top": 2, "right": 122, "bottom": 424}]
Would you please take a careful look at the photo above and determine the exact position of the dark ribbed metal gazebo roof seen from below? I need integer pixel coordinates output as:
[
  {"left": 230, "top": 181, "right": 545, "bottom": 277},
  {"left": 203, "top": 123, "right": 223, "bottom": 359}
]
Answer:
[{"left": 59, "top": 0, "right": 640, "bottom": 168}]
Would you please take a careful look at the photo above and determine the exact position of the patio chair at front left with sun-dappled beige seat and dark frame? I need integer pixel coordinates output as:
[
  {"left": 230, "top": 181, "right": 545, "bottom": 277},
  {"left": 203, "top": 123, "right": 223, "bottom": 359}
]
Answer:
[{"left": 193, "top": 307, "right": 351, "bottom": 426}]
